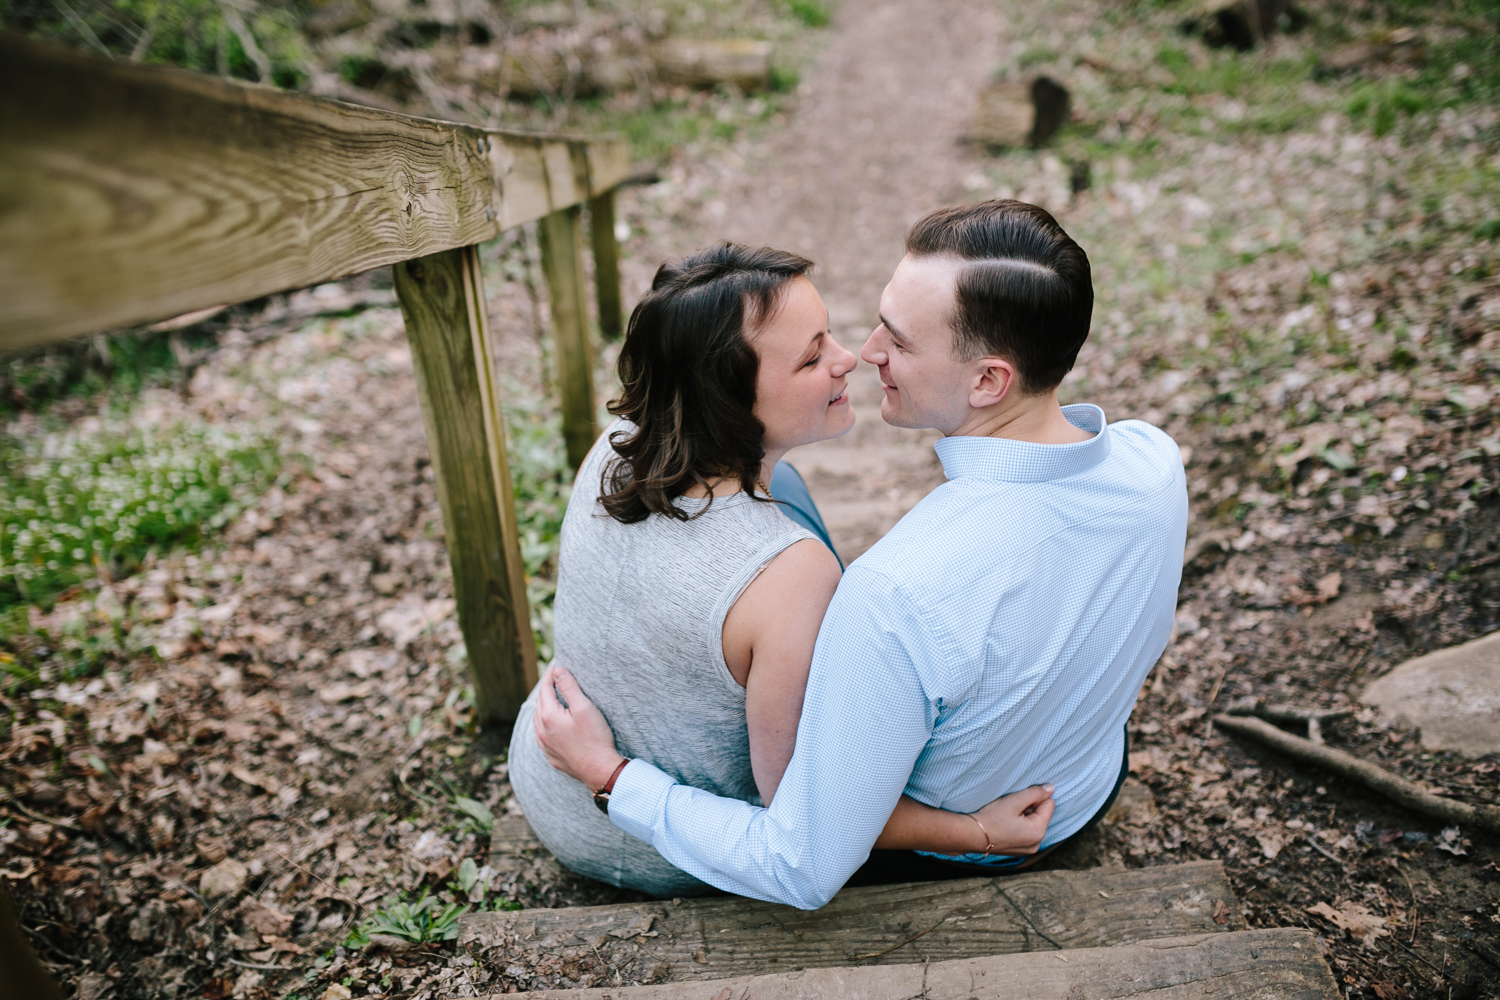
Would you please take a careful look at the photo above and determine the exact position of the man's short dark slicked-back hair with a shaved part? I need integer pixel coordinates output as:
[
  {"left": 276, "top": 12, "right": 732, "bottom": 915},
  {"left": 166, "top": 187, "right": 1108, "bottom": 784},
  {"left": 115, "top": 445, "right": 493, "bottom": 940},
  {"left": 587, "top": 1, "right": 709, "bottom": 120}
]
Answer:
[{"left": 906, "top": 199, "right": 1094, "bottom": 393}]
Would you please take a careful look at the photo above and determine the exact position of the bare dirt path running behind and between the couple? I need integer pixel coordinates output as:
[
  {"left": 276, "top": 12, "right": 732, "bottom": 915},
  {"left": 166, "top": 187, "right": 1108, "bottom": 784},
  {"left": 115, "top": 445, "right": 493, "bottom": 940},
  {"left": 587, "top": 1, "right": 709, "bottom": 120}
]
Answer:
[{"left": 642, "top": 0, "right": 1004, "bottom": 562}]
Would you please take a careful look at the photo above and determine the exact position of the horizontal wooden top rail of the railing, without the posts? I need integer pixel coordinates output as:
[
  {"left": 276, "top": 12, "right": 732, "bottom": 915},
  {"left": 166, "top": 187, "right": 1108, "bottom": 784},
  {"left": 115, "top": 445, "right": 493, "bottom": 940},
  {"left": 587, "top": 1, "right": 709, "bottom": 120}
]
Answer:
[{"left": 0, "top": 33, "right": 629, "bottom": 349}]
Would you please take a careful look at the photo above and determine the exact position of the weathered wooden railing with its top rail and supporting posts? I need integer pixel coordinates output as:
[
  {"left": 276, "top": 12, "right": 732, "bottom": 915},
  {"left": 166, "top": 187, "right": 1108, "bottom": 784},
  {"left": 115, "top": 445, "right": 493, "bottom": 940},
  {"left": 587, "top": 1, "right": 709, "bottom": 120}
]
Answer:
[{"left": 0, "top": 33, "right": 630, "bottom": 721}]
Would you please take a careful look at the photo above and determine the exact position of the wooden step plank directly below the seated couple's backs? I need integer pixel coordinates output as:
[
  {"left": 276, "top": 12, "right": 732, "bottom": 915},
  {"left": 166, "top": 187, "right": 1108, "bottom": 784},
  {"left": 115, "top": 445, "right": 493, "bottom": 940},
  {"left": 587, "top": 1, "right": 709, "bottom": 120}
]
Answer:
[{"left": 459, "top": 861, "right": 1244, "bottom": 981}]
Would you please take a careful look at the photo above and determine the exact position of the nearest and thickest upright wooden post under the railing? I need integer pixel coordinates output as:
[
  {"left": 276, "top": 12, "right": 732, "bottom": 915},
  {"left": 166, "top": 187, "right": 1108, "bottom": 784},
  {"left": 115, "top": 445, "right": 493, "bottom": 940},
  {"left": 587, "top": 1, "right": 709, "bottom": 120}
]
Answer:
[{"left": 393, "top": 246, "right": 537, "bottom": 723}]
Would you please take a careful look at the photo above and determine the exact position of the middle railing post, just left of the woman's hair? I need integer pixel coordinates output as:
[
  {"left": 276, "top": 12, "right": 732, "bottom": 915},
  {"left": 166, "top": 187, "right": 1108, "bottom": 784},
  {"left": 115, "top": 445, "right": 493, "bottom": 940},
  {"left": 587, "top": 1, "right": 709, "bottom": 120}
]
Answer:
[{"left": 537, "top": 205, "right": 599, "bottom": 469}]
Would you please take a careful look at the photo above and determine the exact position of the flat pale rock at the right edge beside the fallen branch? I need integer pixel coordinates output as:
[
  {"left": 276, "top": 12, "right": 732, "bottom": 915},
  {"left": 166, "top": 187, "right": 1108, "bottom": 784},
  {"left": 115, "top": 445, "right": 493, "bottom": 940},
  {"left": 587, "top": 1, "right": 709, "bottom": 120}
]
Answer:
[{"left": 1361, "top": 633, "right": 1500, "bottom": 757}]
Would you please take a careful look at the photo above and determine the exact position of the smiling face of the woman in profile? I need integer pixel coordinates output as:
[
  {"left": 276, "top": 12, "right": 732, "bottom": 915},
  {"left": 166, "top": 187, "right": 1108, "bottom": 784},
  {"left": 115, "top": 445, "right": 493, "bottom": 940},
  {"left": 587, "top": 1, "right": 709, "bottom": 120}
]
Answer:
[{"left": 750, "top": 277, "right": 858, "bottom": 453}]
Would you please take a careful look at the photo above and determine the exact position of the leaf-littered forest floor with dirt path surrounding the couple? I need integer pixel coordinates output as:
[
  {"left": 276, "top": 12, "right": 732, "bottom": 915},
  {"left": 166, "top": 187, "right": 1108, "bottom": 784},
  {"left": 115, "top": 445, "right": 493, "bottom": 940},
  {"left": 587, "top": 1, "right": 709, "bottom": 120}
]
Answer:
[{"left": 0, "top": 0, "right": 1500, "bottom": 1000}]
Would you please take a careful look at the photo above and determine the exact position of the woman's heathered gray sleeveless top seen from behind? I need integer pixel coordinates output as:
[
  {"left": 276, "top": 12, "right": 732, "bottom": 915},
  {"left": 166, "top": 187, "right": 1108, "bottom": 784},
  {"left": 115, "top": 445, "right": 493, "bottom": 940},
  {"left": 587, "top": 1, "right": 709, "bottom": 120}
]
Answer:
[{"left": 510, "top": 420, "right": 813, "bottom": 898}]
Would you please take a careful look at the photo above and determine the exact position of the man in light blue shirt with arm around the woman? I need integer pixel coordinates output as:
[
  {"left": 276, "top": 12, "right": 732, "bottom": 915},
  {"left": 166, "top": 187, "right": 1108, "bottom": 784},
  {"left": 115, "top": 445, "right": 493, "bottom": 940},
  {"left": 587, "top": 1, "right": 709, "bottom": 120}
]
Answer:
[{"left": 537, "top": 201, "right": 1187, "bottom": 909}]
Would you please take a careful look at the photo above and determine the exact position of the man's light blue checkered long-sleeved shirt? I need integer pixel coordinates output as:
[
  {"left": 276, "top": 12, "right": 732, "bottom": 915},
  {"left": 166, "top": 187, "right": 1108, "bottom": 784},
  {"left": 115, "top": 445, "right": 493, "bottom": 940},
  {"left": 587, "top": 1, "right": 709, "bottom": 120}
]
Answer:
[{"left": 609, "top": 405, "right": 1188, "bottom": 909}]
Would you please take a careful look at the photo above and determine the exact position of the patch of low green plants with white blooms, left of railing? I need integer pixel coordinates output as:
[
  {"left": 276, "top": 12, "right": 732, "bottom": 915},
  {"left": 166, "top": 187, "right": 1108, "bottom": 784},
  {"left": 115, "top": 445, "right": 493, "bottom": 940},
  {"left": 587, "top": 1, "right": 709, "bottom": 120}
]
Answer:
[{"left": 0, "top": 424, "right": 278, "bottom": 609}]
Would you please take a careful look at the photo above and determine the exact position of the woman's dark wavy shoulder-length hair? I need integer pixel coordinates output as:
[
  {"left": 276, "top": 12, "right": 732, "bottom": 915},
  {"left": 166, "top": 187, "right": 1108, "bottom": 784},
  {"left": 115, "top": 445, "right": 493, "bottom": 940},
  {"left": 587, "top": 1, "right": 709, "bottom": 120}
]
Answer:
[{"left": 600, "top": 243, "right": 813, "bottom": 525}]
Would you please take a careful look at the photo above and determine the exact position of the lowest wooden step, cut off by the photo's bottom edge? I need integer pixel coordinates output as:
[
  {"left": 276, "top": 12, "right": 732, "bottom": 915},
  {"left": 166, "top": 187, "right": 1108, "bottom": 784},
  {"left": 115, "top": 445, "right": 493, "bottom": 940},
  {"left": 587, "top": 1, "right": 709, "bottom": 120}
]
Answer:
[{"left": 477, "top": 928, "right": 1340, "bottom": 1000}]
